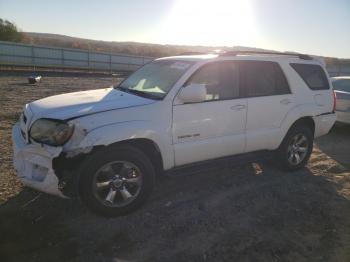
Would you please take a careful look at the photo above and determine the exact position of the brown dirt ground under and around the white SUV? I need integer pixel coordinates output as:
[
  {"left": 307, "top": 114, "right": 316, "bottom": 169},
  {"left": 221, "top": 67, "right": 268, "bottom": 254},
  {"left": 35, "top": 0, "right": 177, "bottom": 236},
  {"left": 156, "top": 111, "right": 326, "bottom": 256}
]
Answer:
[{"left": 0, "top": 72, "right": 350, "bottom": 262}]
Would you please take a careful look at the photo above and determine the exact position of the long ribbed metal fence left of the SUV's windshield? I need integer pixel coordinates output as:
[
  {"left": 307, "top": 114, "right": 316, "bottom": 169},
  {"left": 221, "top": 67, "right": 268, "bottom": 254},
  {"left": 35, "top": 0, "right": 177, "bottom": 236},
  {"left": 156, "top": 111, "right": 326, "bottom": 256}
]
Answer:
[{"left": 0, "top": 41, "right": 154, "bottom": 72}]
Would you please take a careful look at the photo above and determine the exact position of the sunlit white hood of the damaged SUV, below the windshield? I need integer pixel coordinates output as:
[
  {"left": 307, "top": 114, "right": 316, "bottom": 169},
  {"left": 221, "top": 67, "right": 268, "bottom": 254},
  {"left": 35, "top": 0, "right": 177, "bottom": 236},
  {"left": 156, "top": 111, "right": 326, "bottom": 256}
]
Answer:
[{"left": 29, "top": 87, "right": 155, "bottom": 120}]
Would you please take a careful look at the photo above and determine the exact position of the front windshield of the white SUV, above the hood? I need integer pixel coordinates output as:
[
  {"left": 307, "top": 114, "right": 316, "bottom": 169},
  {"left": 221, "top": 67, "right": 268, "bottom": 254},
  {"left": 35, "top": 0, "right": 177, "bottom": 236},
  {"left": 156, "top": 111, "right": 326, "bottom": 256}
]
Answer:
[{"left": 117, "top": 60, "right": 193, "bottom": 99}]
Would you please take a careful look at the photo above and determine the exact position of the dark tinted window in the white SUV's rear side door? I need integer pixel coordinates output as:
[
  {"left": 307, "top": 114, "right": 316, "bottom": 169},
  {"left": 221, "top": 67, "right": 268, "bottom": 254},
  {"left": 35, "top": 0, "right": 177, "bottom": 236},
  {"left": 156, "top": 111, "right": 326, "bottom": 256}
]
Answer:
[{"left": 240, "top": 61, "right": 290, "bottom": 97}]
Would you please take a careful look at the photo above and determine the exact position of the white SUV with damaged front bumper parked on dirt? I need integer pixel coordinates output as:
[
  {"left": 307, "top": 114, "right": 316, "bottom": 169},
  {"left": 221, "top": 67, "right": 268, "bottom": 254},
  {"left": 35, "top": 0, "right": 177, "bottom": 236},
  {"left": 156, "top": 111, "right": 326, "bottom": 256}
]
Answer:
[{"left": 13, "top": 52, "right": 336, "bottom": 216}]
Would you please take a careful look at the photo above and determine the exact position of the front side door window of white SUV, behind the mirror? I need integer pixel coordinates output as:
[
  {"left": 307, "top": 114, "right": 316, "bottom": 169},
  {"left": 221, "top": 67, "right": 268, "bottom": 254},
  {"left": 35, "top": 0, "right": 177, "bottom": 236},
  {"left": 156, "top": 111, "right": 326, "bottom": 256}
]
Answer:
[{"left": 186, "top": 62, "right": 239, "bottom": 101}]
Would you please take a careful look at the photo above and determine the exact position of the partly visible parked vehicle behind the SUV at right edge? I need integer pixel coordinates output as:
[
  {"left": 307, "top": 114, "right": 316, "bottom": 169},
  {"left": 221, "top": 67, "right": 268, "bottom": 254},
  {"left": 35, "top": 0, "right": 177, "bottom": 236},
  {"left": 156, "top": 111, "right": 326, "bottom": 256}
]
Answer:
[{"left": 331, "top": 76, "right": 350, "bottom": 124}]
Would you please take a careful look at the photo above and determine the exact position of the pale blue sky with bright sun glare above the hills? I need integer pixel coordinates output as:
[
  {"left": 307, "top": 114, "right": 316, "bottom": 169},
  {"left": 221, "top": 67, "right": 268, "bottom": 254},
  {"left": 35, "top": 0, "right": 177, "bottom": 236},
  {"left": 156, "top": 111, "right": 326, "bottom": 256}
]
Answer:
[{"left": 0, "top": 0, "right": 350, "bottom": 58}]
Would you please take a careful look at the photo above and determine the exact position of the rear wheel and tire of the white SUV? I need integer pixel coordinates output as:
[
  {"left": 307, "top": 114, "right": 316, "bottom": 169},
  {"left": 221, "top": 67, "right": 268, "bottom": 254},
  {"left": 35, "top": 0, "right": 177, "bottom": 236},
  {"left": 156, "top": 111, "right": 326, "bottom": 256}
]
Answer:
[{"left": 276, "top": 125, "right": 314, "bottom": 171}]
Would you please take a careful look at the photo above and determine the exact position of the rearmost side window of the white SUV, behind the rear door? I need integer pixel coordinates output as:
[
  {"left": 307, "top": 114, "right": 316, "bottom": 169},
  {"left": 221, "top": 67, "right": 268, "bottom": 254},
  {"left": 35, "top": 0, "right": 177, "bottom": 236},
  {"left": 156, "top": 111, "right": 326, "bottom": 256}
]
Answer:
[{"left": 290, "top": 63, "right": 329, "bottom": 90}]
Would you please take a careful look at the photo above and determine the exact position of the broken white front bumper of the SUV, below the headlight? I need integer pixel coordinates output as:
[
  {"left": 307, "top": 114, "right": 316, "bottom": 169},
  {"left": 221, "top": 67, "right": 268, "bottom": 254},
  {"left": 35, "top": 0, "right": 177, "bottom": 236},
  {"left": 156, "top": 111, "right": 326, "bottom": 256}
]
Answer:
[{"left": 12, "top": 123, "right": 67, "bottom": 198}]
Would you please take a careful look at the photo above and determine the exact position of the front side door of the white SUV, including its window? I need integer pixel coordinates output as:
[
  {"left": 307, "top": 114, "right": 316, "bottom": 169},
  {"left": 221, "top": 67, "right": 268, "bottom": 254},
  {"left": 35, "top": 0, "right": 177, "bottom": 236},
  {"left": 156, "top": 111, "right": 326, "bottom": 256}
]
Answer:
[{"left": 173, "top": 61, "right": 247, "bottom": 166}]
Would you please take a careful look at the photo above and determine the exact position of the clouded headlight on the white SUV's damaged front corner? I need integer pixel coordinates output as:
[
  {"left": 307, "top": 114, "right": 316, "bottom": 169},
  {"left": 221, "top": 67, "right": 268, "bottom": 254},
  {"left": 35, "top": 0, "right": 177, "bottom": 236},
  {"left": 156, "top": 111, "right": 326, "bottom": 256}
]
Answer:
[{"left": 29, "top": 118, "right": 74, "bottom": 146}]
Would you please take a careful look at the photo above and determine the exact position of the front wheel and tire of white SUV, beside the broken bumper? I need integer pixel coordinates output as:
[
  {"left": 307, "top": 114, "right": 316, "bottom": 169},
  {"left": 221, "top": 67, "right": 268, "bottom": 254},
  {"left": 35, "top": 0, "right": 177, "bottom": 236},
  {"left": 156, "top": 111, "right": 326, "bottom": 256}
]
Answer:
[{"left": 79, "top": 146, "right": 155, "bottom": 217}]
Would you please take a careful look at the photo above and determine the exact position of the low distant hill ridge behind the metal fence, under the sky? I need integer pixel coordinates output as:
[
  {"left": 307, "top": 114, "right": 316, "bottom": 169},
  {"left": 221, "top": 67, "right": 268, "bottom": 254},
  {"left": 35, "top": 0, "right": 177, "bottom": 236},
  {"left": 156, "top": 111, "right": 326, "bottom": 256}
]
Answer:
[{"left": 23, "top": 32, "right": 274, "bottom": 57}]
